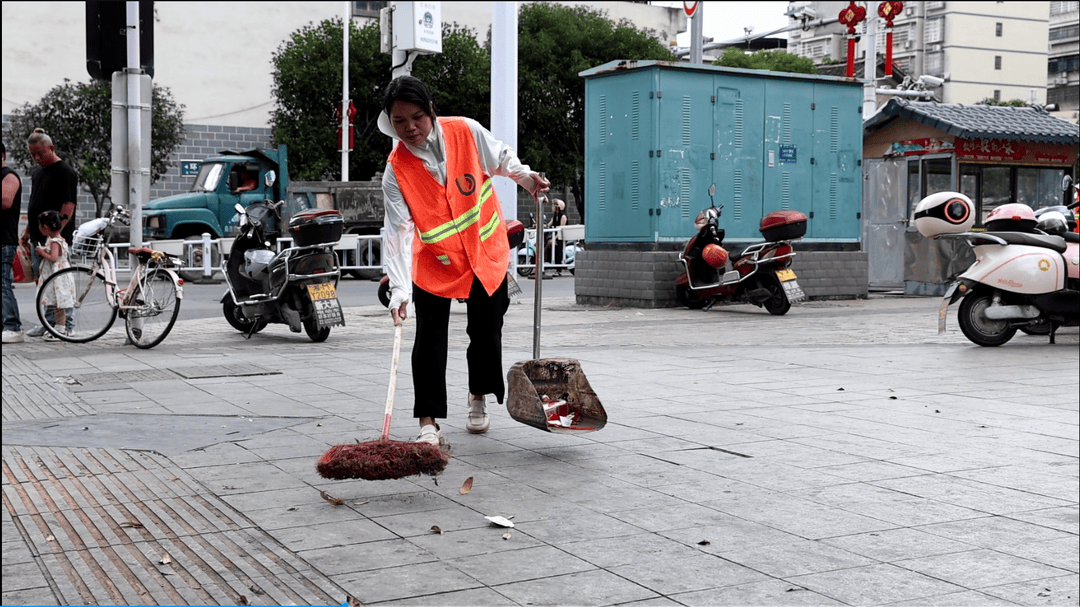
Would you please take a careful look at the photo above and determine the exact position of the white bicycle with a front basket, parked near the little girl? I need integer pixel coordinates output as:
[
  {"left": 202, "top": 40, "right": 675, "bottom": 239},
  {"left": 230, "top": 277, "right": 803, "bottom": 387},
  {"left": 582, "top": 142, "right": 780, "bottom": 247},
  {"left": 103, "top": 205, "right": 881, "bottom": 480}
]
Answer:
[{"left": 36, "top": 206, "right": 184, "bottom": 349}]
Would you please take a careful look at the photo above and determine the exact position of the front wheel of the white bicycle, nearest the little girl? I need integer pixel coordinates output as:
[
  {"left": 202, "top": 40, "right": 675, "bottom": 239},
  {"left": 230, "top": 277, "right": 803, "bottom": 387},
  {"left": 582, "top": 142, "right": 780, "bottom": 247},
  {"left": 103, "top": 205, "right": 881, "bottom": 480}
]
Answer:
[{"left": 36, "top": 266, "right": 117, "bottom": 343}]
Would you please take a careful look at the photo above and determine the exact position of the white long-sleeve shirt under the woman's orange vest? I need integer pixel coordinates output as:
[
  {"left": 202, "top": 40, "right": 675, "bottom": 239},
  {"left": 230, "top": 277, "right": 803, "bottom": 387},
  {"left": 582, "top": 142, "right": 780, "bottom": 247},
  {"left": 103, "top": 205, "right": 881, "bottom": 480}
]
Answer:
[{"left": 379, "top": 118, "right": 536, "bottom": 300}]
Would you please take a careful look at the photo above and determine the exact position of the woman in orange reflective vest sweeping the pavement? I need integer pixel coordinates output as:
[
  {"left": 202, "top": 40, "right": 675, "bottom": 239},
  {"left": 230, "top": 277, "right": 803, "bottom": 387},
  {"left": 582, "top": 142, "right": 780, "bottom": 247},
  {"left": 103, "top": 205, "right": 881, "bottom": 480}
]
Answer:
[{"left": 379, "top": 76, "right": 551, "bottom": 445}]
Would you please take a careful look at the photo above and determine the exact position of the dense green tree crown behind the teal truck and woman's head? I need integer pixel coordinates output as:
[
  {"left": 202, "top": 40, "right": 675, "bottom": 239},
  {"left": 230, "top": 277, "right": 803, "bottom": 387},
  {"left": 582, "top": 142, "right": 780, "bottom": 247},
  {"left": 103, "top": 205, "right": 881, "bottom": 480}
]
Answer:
[{"left": 270, "top": 18, "right": 490, "bottom": 180}]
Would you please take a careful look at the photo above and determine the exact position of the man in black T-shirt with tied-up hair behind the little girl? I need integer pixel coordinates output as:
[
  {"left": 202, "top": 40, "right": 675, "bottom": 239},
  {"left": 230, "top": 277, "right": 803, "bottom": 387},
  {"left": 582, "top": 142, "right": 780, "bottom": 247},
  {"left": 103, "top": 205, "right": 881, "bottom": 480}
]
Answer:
[{"left": 19, "top": 129, "right": 79, "bottom": 337}]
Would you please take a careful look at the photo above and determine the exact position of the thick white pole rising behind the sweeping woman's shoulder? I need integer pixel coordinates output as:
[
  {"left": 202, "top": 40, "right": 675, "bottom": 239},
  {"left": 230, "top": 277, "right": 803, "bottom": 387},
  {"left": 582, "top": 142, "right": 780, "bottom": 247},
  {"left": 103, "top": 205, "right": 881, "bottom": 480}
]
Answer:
[{"left": 491, "top": 2, "right": 518, "bottom": 225}]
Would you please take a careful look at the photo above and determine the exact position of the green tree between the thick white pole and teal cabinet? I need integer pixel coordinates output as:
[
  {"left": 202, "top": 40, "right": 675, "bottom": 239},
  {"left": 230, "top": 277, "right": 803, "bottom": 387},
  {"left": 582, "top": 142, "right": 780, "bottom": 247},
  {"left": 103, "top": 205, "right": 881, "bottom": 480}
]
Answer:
[{"left": 517, "top": 2, "right": 675, "bottom": 217}]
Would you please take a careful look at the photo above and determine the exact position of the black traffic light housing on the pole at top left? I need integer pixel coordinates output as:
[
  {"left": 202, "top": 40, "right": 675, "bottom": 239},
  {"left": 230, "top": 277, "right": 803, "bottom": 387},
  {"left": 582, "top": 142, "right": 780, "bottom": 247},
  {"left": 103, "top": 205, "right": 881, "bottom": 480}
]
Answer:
[{"left": 86, "top": 0, "right": 153, "bottom": 82}]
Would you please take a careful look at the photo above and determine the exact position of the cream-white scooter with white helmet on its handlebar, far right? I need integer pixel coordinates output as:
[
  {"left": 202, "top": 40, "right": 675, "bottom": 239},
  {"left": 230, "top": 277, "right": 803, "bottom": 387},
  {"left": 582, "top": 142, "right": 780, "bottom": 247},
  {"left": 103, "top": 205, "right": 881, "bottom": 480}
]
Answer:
[{"left": 914, "top": 184, "right": 1080, "bottom": 347}]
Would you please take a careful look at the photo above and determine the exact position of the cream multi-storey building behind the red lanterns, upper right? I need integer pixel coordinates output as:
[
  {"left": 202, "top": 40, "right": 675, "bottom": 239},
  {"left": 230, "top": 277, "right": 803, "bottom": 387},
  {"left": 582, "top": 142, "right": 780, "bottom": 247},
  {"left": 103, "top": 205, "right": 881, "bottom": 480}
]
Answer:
[{"left": 788, "top": 1, "right": 1054, "bottom": 105}]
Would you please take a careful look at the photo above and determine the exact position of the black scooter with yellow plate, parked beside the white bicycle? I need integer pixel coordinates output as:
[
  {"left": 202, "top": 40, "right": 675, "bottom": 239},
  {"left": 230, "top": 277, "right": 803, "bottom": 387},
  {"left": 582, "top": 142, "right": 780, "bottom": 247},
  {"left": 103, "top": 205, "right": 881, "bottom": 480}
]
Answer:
[{"left": 221, "top": 174, "right": 345, "bottom": 342}]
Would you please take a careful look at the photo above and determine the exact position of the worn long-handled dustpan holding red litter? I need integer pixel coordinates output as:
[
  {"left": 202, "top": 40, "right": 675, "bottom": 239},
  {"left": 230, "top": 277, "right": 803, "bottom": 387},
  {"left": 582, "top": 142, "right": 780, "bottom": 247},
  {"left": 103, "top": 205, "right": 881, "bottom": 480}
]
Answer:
[{"left": 507, "top": 187, "right": 607, "bottom": 434}]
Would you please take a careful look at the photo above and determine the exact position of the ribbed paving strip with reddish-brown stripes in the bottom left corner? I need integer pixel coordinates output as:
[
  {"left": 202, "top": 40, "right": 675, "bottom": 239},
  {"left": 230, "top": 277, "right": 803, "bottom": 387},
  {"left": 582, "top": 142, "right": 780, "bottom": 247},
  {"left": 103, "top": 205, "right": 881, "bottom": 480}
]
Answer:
[{"left": 3, "top": 446, "right": 346, "bottom": 605}]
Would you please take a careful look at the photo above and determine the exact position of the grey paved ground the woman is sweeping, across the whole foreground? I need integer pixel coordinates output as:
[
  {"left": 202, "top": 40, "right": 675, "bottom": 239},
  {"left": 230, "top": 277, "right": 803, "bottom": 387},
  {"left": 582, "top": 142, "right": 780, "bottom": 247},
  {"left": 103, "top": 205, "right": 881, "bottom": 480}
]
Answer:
[{"left": 2, "top": 297, "right": 1080, "bottom": 605}]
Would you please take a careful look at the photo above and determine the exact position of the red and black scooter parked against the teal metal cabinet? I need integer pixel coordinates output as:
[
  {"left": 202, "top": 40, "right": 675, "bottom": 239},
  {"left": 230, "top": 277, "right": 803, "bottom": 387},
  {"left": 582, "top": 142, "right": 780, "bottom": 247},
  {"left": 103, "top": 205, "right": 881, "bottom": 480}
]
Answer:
[{"left": 675, "top": 184, "right": 807, "bottom": 316}]
